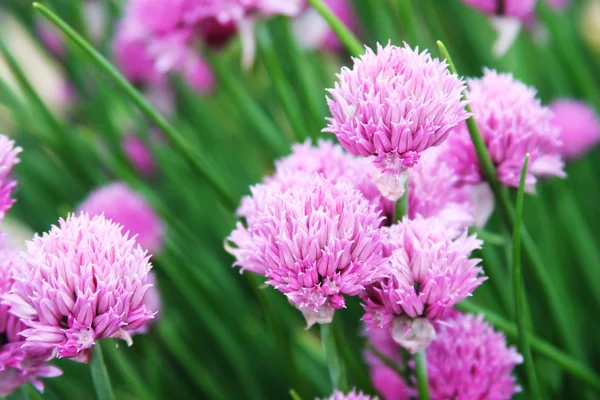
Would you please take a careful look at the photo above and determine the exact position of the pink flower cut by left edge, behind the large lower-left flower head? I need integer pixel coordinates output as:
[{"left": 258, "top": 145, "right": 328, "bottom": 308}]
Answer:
[{"left": 0, "top": 237, "right": 62, "bottom": 396}]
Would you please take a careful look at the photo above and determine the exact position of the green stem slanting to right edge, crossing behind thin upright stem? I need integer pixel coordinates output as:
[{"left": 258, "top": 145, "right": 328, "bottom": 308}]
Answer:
[{"left": 457, "top": 301, "right": 600, "bottom": 391}]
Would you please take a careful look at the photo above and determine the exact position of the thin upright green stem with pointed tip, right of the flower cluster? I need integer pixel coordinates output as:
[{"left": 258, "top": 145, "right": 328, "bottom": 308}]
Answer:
[{"left": 512, "top": 154, "right": 542, "bottom": 400}]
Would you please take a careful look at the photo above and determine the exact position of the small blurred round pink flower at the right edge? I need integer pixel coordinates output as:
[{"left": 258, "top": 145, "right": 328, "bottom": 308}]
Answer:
[{"left": 550, "top": 99, "right": 600, "bottom": 160}]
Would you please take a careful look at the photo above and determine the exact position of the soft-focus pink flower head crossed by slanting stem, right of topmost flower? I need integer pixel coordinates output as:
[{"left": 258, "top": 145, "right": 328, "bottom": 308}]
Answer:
[{"left": 445, "top": 69, "right": 565, "bottom": 191}]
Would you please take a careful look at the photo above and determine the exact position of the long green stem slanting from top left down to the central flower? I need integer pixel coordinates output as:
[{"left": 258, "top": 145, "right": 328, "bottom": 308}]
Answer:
[{"left": 33, "top": 3, "right": 237, "bottom": 211}]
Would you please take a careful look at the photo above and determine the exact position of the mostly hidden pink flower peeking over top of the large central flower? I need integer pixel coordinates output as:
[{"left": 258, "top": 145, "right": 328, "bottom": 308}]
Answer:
[{"left": 266, "top": 139, "right": 394, "bottom": 222}]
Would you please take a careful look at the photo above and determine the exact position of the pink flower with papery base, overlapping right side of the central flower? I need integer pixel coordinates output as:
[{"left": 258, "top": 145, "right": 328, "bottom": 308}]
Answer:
[{"left": 362, "top": 218, "right": 486, "bottom": 352}]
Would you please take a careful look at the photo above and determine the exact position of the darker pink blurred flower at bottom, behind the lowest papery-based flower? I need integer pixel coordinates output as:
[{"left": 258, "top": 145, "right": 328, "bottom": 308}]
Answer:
[{"left": 364, "top": 311, "right": 523, "bottom": 400}]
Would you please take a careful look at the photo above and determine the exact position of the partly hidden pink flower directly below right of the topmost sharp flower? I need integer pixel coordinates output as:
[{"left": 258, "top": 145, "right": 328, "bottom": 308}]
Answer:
[{"left": 408, "top": 145, "right": 494, "bottom": 235}]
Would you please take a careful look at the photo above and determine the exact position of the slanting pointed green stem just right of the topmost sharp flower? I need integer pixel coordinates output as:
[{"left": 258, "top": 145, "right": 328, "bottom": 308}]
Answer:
[{"left": 437, "top": 41, "right": 579, "bottom": 353}]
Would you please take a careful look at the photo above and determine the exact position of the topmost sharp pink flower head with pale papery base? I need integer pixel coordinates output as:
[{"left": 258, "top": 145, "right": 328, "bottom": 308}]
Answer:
[{"left": 325, "top": 45, "right": 468, "bottom": 200}]
